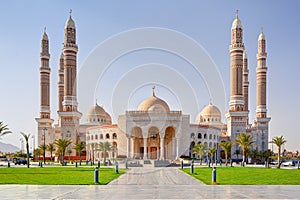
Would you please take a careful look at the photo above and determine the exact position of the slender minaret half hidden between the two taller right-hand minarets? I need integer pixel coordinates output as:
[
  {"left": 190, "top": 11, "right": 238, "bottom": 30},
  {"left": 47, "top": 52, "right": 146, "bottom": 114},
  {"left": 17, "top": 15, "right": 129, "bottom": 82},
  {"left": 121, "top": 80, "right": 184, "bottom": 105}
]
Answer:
[{"left": 243, "top": 50, "right": 249, "bottom": 124}]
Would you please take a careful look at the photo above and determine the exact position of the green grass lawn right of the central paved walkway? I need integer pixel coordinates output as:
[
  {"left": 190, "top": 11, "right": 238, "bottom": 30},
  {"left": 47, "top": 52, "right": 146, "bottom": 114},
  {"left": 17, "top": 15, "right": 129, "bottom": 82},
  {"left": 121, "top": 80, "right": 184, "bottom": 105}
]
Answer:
[{"left": 183, "top": 167, "right": 300, "bottom": 185}]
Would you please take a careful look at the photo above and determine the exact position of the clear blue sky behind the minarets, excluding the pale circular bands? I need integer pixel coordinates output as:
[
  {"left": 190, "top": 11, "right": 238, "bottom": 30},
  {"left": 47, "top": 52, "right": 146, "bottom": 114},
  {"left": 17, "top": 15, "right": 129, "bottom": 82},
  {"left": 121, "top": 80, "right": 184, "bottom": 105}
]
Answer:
[{"left": 0, "top": 0, "right": 300, "bottom": 150}]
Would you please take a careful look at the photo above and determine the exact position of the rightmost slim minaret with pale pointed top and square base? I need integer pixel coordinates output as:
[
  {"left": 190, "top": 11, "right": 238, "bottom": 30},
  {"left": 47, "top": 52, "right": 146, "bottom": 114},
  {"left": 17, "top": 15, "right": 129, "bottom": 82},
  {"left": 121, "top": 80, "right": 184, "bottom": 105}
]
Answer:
[{"left": 254, "top": 32, "right": 271, "bottom": 151}]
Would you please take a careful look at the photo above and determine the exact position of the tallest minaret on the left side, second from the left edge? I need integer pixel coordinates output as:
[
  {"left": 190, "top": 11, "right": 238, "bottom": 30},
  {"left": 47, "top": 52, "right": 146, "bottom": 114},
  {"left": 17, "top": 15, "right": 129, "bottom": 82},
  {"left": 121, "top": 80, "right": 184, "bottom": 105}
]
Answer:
[{"left": 58, "top": 12, "right": 82, "bottom": 155}]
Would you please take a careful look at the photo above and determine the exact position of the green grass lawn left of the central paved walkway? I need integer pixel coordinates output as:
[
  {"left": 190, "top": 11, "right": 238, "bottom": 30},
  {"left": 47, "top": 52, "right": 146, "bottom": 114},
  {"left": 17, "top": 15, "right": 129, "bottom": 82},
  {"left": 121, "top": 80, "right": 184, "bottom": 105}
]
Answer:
[{"left": 0, "top": 167, "right": 126, "bottom": 185}]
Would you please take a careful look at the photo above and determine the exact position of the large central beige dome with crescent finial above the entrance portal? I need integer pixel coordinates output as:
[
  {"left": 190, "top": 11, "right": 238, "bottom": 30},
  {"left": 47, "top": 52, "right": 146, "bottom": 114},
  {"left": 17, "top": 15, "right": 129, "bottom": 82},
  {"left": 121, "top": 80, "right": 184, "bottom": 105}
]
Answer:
[{"left": 138, "top": 87, "right": 170, "bottom": 112}]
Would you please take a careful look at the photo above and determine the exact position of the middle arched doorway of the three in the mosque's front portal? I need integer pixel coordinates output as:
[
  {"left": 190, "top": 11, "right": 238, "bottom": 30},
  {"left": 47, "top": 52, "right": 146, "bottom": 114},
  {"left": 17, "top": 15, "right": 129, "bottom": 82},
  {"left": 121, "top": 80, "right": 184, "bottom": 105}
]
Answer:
[{"left": 147, "top": 127, "right": 160, "bottom": 160}]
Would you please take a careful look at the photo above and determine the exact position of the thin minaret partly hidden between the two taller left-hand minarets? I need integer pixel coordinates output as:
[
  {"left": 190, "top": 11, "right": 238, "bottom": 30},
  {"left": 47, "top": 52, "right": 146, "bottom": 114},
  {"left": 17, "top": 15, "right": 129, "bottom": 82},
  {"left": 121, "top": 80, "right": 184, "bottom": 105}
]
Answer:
[{"left": 58, "top": 53, "right": 64, "bottom": 112}]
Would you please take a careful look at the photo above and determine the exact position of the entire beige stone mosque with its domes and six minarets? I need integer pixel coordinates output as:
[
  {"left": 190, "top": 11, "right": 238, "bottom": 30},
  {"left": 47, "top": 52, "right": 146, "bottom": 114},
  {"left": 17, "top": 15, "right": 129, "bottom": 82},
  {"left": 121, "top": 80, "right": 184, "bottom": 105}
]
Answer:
[{"left": 36, "top": 11, "right": 271, "bottom": 164}]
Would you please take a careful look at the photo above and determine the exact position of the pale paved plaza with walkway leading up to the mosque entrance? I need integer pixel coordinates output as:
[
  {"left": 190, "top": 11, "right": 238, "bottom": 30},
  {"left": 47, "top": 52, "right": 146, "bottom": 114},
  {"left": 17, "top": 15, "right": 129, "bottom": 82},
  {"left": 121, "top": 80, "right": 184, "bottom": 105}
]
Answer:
[{"left": 0, "top": 168, "right": 300, "bottom": 199}]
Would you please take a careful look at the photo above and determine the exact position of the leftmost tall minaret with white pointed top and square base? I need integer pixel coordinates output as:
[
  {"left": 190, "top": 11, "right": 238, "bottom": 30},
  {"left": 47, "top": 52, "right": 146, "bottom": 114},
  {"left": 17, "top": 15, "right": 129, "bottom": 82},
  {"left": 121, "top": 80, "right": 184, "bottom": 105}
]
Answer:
[{"left": 35, "top": 29, "right": 53, "bottom": 145}]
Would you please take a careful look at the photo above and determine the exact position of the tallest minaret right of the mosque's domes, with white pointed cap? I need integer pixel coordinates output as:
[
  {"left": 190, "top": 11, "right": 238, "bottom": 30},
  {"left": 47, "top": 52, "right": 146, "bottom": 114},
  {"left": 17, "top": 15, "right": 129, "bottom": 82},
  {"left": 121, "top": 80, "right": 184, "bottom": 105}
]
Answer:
[{"left": 226, "top": 12, "right": 249, "bottom": 158}]
